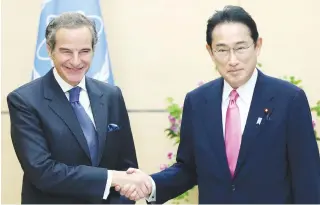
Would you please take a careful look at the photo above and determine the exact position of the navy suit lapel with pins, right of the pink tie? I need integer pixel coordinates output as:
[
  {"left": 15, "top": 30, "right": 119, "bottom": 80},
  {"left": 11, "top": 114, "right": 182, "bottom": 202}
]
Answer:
[{"left": 235, "top": 71, "right": 273, "bottom": 176}]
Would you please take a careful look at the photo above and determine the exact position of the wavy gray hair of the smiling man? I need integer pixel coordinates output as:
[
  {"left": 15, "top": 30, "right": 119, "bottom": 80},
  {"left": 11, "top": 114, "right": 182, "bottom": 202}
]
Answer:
[{"left": 45, "top": 12, "right": 98, "bottom": 50}]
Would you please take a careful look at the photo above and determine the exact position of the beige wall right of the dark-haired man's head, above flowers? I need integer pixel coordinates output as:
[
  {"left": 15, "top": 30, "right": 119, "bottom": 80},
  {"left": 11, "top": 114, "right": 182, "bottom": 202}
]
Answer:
[{"left": 241, "top": 0, "right": 320, "bottom": 105}]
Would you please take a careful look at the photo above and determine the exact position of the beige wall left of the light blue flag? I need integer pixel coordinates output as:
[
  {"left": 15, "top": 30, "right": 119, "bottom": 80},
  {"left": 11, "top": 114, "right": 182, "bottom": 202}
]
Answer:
[{"left": 1, "top": 0, "right": 42, "bottom": 110}]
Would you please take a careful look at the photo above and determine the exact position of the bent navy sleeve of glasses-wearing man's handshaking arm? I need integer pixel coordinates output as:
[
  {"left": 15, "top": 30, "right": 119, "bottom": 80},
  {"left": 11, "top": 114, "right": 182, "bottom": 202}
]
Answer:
[{"left": 151, "top": 96, "right": 197, "bottom": 204}]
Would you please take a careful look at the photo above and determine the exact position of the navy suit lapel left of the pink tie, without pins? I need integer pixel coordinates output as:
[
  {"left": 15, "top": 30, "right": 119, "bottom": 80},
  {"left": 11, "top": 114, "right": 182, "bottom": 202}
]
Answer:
[{"left": 202, "top": 78, "right": 230, "bottom": 178}]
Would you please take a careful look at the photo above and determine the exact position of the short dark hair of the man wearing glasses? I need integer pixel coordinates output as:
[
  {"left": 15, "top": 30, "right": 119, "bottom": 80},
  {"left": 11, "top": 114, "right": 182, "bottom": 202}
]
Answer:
[{"left": 206, "top": 5, "right": 259, "bottom": 47}]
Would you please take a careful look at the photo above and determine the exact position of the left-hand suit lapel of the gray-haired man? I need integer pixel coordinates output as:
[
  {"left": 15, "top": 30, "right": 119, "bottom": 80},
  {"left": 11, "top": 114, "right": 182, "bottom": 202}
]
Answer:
[{"left": 43, "top": 70, "right": 91, "bottom": 159}]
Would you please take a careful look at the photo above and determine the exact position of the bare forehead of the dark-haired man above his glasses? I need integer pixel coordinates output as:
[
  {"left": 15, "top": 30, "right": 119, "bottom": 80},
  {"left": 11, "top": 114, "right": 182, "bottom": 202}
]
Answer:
[{"left": 212, "top": 22, "right": 253, "bottom": 46}]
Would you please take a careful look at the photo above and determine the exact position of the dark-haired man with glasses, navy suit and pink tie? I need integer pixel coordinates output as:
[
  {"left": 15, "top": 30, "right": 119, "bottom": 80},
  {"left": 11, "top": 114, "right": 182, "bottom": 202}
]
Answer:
[{"left": 116, "top": 6, "right": 320, "bottom": 204}]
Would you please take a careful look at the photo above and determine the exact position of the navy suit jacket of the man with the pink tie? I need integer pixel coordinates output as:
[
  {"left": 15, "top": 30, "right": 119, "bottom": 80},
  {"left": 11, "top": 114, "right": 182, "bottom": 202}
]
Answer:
[{"left": 152, "top": 71, "right": 320, "bottom": 204}]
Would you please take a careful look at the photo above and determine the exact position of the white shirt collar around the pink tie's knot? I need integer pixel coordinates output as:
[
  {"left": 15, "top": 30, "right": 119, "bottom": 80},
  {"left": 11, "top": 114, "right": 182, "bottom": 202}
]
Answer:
[{"left": 222, "top": 68, "right": 258, "bottom": 104}]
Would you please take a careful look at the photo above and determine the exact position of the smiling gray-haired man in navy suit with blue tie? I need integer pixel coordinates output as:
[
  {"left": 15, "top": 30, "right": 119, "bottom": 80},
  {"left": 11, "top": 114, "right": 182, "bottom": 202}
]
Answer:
[{"left": 7, "top": 13, "right": 152, "bottom": 204}]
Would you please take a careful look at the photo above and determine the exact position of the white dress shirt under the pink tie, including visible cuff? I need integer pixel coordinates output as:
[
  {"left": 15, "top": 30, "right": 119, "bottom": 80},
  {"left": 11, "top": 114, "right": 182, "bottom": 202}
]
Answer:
[{"left": 148, "top": 69, "right": 258, "bottom": 202}]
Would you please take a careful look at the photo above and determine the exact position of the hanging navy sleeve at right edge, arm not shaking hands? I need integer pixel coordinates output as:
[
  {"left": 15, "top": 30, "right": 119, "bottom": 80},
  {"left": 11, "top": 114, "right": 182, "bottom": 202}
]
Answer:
[{"left": 287, "top": 90, "right": 320, "bottom": 204}]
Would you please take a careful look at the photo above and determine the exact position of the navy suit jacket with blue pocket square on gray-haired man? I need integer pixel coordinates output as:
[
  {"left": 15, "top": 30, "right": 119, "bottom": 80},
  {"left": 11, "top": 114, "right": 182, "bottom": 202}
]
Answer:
[{"left": 7, "top": 70, "right": 138, "bottom": 204}]
